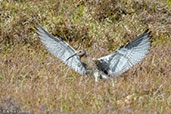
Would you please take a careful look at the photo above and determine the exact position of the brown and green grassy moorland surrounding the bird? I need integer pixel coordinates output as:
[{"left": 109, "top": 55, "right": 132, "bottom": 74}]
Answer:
[{"left": 0, "top": 0, "right": 171, "bottom": 114}]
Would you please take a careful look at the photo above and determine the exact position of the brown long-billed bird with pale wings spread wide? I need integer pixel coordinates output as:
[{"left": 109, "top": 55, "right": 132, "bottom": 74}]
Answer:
[{"left": 36, "top": 23, "right": 152, "bottom": 82}]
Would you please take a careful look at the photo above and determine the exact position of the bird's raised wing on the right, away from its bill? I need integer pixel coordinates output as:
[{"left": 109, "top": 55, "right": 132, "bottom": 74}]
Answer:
[{"left": 98, "top": 30, "right": 151, "bottom": 76}]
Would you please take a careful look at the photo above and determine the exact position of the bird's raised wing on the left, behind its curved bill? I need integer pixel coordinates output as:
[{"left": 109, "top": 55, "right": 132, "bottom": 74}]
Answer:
[{"left": 37, "top": 24, "right": 86, "bottom": 75}]
